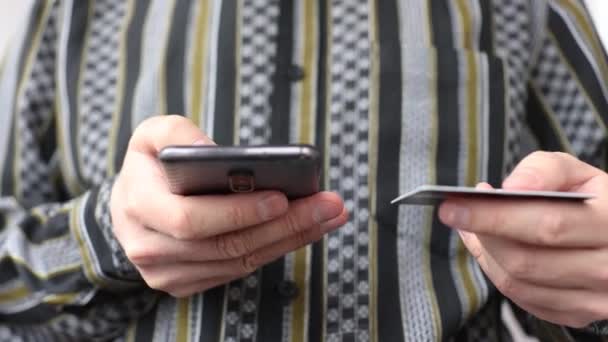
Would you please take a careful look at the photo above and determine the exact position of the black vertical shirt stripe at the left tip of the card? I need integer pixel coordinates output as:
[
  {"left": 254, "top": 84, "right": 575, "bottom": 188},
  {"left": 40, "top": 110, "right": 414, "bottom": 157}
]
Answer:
[{"left": 375, "top": 0, "right": 408, "bottom": 341}]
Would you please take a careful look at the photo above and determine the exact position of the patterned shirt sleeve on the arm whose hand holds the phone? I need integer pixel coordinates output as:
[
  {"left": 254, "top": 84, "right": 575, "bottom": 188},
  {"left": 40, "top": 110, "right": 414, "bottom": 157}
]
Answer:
[{"left": 0, "top": 1, "right": 156, "bottom": 340}]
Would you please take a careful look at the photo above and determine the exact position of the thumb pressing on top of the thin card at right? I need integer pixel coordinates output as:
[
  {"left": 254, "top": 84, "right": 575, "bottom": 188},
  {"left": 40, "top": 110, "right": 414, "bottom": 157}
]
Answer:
[{"left": 502, "top": 152, "right": 603, "bottom": 191}]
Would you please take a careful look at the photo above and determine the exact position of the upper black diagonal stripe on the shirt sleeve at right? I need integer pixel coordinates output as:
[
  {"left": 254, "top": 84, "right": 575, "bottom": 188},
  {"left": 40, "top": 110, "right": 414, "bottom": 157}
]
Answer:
[{"left": 548, "top": 7, "right": 608, "bottom": 123}]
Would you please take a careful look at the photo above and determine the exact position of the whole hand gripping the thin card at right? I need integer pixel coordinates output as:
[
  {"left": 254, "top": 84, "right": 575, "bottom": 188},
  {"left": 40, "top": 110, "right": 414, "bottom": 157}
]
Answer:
[{"left": 439, "top": 152, "right": 608, "bottom": 328}]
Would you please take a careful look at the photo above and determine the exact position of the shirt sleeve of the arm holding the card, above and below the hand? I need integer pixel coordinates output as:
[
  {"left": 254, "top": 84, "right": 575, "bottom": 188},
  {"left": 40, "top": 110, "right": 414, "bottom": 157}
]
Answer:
[{"left": 520, "top": 0, "right": 608, "bottom": 340}]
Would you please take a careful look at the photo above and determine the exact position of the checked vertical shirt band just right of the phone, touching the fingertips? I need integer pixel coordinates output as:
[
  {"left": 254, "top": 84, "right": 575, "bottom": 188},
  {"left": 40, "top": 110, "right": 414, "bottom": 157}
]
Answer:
[{"left": 324, "top": 0, "right": 371, "bottom": 342}]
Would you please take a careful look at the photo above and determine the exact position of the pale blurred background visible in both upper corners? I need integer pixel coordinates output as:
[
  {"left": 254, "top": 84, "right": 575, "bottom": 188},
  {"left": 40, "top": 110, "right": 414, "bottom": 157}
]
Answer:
[{"left": 0, "top": 0, "right": 608, "bottom": 55}]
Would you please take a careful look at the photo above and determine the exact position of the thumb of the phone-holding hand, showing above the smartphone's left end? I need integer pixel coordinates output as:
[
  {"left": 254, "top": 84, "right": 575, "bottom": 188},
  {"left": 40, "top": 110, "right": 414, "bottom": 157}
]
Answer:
[{"left": 129, "top": 115, "right": 215, "bottom": 155}]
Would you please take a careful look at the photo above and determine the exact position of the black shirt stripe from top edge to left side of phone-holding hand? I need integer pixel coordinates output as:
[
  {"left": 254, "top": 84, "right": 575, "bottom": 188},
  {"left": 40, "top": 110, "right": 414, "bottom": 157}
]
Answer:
[{"left": 114, "top": 1, "right": 150, "bottom": 172}]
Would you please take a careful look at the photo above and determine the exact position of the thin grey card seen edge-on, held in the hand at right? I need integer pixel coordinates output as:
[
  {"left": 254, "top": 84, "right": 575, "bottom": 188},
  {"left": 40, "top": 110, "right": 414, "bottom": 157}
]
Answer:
[{"left": 391, "top": 185, "right": 595, "bottom": 205}]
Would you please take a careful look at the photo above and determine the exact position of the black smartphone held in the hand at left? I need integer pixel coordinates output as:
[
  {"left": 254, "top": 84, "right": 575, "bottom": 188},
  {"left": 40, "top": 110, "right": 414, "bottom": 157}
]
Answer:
[{"left": 158, "top": 145, "right": 321, "bottom": 199}]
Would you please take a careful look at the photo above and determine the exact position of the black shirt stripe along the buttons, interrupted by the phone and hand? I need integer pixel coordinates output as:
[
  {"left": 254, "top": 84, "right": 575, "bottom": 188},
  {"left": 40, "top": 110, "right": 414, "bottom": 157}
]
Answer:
[{"left": 257, "top": 0, "right": 294, "bottom": 341}]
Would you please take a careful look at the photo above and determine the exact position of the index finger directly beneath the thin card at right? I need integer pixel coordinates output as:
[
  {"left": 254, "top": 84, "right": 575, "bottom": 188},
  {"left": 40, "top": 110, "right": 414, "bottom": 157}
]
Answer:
[{"left": 439, "top": 198, "right": 608, "bottom": 247}]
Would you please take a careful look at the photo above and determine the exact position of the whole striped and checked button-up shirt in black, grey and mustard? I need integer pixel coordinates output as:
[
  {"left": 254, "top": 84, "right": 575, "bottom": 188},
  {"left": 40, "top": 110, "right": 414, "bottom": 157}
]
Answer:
[{"left": 0, "top": 0, "right": 608, "bottom": 342}]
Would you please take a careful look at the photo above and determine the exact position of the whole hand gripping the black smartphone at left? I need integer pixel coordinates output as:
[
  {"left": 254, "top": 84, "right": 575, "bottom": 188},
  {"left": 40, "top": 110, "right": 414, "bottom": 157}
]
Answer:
[{"left": 111, "top": 116, "right": 348, "bottom": 297}]
